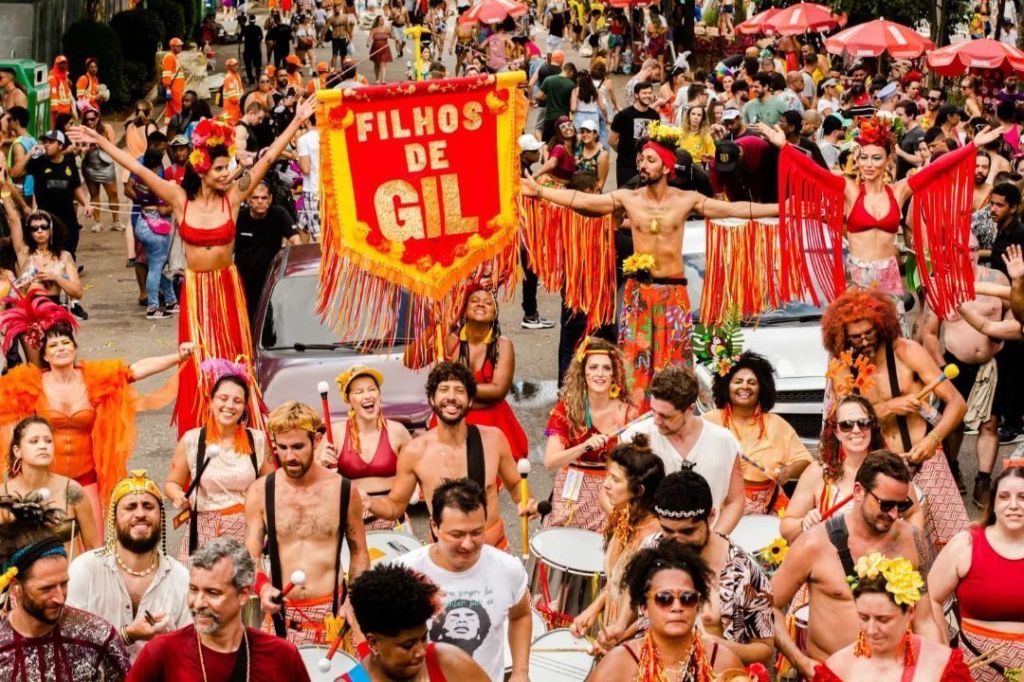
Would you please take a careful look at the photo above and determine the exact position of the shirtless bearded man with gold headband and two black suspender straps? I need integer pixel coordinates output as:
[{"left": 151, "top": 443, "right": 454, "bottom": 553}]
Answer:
[{"left": 246, "top": 400, "right": 370, "bottom": 645}]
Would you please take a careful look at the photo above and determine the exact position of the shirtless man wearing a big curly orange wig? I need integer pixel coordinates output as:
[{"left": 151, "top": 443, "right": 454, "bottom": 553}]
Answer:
[{"left": 821, "top": 291, "right": 968, "bottom": 547}]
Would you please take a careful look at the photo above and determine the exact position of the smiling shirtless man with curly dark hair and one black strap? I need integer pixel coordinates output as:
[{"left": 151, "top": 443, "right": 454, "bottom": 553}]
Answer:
[{"left": 360, "top": 363, "right": 536, "bottom": 549}]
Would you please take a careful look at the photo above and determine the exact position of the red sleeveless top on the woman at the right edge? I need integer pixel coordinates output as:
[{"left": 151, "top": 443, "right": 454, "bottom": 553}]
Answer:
[{"left": 956, "top": 528, "right": 1024, "bottom": 621}]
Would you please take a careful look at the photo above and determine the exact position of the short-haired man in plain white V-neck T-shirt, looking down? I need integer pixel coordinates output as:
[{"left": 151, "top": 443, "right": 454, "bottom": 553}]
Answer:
[{"left": 622, "top": 365, "right": 744, "bottom": 536}]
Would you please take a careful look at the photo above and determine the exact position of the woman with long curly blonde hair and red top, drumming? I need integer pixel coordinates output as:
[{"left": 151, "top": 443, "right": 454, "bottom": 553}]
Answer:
[{"left": 544, "top": 337, "right": 639, "bottom": 532}]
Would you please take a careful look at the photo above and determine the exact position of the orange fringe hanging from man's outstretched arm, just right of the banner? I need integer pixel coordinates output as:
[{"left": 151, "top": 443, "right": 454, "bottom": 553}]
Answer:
[{"left": 519, "top": 196, "right": 616, "bottom": 333}]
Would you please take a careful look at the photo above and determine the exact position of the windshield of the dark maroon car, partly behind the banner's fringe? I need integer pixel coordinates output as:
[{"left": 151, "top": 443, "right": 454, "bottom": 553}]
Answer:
[{"left": 260, "top": 274, "right": 409, "bottom": 353}]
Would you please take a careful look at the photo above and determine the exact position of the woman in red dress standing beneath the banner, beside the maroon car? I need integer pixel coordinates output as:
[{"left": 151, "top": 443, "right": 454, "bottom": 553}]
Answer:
[{"left": 440, "top": 287, "right": 529, "bottom": 461}]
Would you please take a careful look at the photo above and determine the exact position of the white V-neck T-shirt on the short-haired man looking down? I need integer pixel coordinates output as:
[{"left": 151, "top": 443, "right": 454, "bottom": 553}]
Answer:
[{"left": 622, "top": 417, "right": 739, "bottom": 515}]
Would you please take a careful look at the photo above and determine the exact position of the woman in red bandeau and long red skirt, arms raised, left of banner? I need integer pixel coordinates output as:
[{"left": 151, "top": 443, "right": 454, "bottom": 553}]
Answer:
[{"left": 70, "top": 98, "right": 314, "bottom": 438}]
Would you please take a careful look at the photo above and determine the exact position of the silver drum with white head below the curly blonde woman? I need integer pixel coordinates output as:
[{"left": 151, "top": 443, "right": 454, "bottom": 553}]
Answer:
[{"left": 529, "top": 528, "right": 605, "bottom": 628}]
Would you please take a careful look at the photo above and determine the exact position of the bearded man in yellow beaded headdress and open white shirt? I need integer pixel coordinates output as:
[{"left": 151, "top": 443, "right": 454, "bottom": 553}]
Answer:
[{"left": 67, "top": 470, "right": 191, "bottom": 660}]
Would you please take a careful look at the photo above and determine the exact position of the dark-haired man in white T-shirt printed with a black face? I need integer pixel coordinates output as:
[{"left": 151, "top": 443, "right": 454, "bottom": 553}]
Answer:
[{"left": 396, "top": 478, "right": 534, "bottom": 682}]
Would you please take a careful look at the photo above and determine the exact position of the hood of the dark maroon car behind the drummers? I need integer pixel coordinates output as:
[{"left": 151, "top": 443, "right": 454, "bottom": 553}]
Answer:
[{"left": 257, "top": 350, "right": 430, "bottom": 428}]
